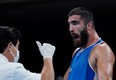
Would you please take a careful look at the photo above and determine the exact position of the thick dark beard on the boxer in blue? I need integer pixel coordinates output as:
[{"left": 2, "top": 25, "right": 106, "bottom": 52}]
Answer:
[{"left": 73, "top": 28, "right": 89, "bottom": 47}]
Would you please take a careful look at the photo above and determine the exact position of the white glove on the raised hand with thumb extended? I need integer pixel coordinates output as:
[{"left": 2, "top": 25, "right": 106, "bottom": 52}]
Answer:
[{"left": 36, "top": 41, "right": 55, "bottom": 59}]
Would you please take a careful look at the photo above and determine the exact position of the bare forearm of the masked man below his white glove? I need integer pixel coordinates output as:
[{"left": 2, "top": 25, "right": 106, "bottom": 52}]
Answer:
[{"left": 41, "top": 58, "right": 54, "bottom": 80}]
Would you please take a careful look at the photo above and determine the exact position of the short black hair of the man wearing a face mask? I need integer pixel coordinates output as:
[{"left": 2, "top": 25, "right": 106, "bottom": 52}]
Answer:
[{"left": 0, "top": 26, "right": 21, "bottom": 53}]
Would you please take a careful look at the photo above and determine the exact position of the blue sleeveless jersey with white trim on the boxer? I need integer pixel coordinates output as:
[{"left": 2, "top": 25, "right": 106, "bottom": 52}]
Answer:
[{"left": 68, "top": 38, "right": 103, "bottom": 80}]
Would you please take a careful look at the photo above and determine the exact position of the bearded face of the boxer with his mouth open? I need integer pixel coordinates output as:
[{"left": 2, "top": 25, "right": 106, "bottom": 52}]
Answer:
[{"left": 68, "top": 15, "right": 88, "bottom": 47}]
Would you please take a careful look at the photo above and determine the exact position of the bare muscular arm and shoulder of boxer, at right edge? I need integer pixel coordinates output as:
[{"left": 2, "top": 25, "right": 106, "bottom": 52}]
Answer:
[{"left": 95, "top": 44, "right": 115, "bottom": 80}]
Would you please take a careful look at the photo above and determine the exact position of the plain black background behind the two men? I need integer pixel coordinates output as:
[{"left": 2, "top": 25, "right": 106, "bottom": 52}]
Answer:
[{"left": 0, "top": 0, "right": 116, "bottom": 80}]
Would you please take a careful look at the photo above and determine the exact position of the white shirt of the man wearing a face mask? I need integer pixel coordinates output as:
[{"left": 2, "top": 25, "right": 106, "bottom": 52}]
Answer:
[{"left": 0, "top": 54, "right": 41, "bottom": 80}]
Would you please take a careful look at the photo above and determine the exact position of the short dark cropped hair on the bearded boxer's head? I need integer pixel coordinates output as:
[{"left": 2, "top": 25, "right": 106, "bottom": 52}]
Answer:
[{"left": 68, "top": 7, "right": 94, "bottom": 25}]
